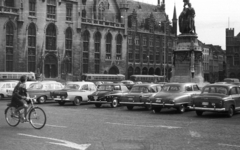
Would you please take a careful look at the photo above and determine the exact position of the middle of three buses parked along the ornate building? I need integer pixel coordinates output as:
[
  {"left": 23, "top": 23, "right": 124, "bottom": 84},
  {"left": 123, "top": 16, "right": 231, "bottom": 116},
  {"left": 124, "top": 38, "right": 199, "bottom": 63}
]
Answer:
[{"left": 82, "top": 74, "right": 125, "bottom": 82}]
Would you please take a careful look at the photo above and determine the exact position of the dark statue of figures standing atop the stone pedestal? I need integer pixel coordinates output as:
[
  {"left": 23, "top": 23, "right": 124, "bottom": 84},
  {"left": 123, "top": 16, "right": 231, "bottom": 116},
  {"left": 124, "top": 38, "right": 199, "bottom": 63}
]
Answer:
[{"left": 179, "top": 0, "right": 196, "bottom": 34}]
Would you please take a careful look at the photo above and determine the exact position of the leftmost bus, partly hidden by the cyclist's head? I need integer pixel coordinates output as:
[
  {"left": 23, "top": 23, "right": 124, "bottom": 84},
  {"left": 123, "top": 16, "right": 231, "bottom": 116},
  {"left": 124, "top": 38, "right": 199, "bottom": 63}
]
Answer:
[{"left": 0, "top": 72, "right": 36, "bottom": 81}]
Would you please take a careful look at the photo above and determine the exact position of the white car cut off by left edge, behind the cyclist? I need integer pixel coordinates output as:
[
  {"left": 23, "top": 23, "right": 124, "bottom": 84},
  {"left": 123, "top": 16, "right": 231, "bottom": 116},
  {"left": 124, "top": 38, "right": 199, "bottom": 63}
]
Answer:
[{"left": 0, "top": 81, "right": 18, "bottom": 99}]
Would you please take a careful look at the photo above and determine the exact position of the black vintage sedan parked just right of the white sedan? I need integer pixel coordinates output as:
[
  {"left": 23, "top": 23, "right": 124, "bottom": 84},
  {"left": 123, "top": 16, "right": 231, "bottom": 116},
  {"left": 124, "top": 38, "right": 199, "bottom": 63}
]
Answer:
[{"left": 88, "top": 83, "right": 129, "bottom": 108}]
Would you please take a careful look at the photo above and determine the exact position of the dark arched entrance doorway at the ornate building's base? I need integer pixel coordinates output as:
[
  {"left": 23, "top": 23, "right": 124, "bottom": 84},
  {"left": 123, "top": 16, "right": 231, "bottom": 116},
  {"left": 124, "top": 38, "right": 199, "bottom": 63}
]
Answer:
[{"left": 44, "top": 55, "right": 58, "bottom": 78}]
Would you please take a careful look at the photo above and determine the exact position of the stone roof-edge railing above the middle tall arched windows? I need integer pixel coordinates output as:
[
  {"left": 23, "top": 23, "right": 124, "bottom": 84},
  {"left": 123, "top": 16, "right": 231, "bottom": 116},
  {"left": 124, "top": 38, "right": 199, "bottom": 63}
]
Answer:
[{"left": 82, "top": 18, "right": 125, "bottom": 28}]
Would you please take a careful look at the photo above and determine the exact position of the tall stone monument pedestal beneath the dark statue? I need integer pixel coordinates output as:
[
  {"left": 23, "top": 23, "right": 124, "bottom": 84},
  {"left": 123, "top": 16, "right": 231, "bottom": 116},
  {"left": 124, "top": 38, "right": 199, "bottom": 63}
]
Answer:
[{"left": 170, "top": 33, "right": 204, "bottom": 84}]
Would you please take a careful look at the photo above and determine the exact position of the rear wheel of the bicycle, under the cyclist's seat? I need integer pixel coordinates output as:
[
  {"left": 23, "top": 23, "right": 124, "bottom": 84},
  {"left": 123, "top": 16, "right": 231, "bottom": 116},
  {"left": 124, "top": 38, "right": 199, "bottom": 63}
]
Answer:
[{"left": 5, "top": 106, "right": 20, "bottom": 127}]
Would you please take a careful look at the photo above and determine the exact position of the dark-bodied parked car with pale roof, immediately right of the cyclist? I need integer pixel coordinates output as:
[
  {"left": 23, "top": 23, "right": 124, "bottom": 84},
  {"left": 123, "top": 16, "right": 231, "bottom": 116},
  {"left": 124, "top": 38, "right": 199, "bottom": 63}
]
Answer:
[{"left": 27, "top": 81, "right": 64, "bottom": 104}]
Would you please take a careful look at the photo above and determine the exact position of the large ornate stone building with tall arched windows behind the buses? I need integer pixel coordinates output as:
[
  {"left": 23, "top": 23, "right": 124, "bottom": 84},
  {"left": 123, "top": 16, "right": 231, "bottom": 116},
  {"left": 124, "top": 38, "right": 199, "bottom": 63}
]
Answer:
[{"left": 0, "top": 0, "right": 177, "bottom": 80}]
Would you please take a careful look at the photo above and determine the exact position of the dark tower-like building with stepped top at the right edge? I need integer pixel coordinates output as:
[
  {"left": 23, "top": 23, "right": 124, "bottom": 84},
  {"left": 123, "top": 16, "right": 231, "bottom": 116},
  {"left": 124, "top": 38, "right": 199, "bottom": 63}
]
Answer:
[{"left": 226, "top": 28, "right": 240, "bottom": 79}]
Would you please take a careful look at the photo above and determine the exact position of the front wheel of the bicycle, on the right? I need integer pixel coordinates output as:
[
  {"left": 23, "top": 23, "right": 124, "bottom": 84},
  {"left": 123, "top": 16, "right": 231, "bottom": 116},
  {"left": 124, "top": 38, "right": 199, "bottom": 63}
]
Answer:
[{"left": 29, "top": 107, "right": 47, "bottom": 129}]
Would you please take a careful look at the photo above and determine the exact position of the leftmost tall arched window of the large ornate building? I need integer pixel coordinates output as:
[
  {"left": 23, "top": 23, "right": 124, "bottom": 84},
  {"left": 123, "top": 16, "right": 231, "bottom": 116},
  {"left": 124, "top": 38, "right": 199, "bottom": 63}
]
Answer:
[{"left": 6, "top": 22, "right": 14, "bottom": 71}]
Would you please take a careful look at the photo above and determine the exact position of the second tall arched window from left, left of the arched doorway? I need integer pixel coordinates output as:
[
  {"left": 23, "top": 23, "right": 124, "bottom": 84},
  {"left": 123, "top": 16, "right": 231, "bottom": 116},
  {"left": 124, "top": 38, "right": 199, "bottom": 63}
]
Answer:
[{"left": 28, "top": 23, "right": 36, "bottom": 72}]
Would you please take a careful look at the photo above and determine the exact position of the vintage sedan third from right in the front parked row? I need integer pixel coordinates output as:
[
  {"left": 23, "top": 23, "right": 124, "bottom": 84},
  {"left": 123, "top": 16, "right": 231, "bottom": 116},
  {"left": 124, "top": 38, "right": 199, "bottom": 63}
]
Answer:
[{"left": 120, "top": 83, "right": 161, "bottom": 110}]
